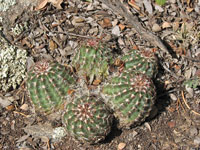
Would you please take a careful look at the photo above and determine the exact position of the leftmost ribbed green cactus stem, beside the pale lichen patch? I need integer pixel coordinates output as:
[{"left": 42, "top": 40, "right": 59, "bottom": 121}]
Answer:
[{"left": 27, "top": 60, "right": 75, "bottom": 112}]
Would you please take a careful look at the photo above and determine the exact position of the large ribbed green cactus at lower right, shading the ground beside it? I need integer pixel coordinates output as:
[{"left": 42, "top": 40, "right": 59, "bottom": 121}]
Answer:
[{"left": 102, "top": 71, "right": 155, "bottom": 128}]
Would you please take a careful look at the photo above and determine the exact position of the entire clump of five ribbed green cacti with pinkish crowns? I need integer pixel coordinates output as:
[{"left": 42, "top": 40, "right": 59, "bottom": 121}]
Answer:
[{"left": 27, "top": 40, "right": 156, "bottom": 143}]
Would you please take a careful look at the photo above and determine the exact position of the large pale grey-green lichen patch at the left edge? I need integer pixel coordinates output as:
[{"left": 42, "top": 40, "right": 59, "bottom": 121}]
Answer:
[{"left": 0, "top": 36, "right": 27, "bottom": 91}]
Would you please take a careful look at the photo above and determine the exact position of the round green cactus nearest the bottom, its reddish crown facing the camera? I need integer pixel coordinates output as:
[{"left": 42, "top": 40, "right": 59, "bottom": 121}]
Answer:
[{"left": 63, "top": 96, "right": 113, "bottom": 144}]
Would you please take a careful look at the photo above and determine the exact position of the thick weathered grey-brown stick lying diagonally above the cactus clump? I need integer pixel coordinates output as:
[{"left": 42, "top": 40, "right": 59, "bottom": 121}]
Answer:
[{"left": 99, "top": 0, "right": 168, "bottom": 53}]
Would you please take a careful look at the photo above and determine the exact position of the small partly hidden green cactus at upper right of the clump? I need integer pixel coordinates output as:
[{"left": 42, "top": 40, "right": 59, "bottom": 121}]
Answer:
[{"left": 122, "top": 50, "right": 158, "bottom": 78}]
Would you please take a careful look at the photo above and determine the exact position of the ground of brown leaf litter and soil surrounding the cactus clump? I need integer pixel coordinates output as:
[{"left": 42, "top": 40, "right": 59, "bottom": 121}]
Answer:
[{"left": 0, "top": 0, "right": 200, "bottom": 150}]
